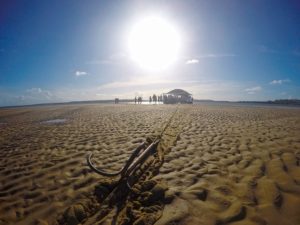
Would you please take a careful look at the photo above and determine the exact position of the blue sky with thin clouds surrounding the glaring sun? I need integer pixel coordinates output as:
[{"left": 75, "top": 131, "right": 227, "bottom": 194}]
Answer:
[{"left": 0, "top": 0, "right": 300, "bottom": 106}]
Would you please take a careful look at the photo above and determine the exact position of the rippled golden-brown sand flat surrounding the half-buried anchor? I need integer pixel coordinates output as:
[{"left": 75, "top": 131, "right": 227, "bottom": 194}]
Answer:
[{"left": 0, "top": 104, "right": 300, "bottom": 225}]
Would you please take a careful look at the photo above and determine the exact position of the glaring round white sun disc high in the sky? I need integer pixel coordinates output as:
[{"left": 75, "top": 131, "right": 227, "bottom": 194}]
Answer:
[{"left": 128, "top": 17, "right": 180, "bottom": 70}]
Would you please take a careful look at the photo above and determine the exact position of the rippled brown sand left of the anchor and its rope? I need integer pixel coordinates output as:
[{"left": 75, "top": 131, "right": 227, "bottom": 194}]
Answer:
[{"left": 0, "top": 105, "right": 174, "bottom": 224}]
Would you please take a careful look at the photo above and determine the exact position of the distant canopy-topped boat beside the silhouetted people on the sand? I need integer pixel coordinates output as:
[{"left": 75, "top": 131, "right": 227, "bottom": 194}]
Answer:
[{"left": 163, "top": 89, "right": 193, "bottom": 104}]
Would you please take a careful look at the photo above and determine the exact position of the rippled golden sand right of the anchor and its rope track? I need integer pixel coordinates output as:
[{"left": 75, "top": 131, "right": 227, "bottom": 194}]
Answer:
[{"left": 156, "top": 106, "right": 300, "bottom": 225}]
